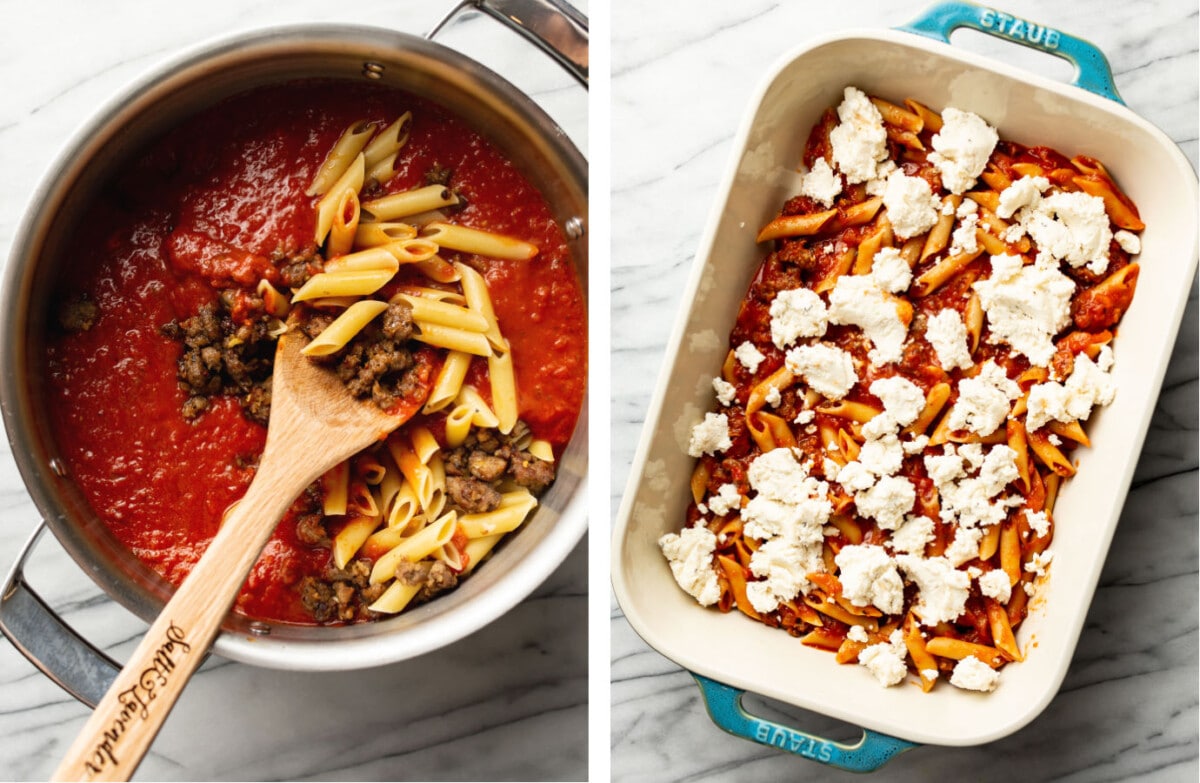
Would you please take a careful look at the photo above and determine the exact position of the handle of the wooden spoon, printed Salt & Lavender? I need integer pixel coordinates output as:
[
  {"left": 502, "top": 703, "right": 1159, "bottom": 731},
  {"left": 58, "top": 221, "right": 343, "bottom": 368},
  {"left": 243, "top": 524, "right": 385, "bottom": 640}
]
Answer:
[{"left": 52, "top": 459, "right": 302, "bottom": 781}]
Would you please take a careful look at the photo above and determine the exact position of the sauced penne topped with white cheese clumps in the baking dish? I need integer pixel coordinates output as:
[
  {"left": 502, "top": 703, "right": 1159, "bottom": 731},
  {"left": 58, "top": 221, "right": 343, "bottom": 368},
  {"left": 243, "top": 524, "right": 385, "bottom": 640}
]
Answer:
[{"left": 659, "top": 88, "right": 1144, "bottom": 691}]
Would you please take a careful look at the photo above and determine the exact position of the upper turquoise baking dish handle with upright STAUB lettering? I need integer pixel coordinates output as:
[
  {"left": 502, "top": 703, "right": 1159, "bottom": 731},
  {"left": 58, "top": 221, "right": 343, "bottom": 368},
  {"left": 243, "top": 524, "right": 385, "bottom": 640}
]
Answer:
[{"left": 898, "top": 2, "right": 1124, "bottom": 106}]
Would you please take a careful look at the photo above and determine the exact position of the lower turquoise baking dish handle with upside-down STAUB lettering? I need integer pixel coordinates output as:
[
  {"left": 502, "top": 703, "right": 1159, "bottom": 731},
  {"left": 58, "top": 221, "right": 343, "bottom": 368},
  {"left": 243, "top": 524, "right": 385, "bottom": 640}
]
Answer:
[{"left": 691, "top": 671, "right": 917, "bottom": 772}]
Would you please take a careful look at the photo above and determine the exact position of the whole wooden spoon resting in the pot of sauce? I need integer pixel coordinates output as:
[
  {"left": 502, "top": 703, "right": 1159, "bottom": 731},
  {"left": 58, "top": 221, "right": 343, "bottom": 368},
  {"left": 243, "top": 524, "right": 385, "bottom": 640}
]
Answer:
[{"left": 53, "top": 331, "right": 428, "bottom": 781}]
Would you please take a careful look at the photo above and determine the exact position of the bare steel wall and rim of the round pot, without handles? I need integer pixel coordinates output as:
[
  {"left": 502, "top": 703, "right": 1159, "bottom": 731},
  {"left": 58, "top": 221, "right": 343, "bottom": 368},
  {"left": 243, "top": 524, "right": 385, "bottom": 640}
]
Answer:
[{"left": 2, "top": 26, "right": 587, "bottom": 668}]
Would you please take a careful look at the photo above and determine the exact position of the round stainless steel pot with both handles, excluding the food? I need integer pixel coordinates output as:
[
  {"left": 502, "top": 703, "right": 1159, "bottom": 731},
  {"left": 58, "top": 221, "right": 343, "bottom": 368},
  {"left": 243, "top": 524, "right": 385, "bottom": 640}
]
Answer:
[{"left": 0, "top": 0, "right": 588, "bottom": 704}]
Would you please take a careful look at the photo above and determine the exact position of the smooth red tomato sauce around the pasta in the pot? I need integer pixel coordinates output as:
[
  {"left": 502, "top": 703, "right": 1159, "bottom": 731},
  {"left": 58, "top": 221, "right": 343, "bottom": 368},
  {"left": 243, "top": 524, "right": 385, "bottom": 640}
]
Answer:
[{"left": 46, "top": 83, "right": 587, "bottom": 624}]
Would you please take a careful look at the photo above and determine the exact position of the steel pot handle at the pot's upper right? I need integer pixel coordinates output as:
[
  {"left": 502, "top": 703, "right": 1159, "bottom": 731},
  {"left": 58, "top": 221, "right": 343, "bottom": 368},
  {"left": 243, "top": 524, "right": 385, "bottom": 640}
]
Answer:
[{"left": 425, "top": 0, "right": 588, "bottom": 89}]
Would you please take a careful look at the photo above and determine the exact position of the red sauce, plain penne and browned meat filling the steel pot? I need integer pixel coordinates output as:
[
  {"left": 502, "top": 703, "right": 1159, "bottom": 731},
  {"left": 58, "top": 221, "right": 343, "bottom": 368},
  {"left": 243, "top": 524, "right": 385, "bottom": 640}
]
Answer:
[{"left": 47, "top": 82, "right": 586, "bottom": 624}]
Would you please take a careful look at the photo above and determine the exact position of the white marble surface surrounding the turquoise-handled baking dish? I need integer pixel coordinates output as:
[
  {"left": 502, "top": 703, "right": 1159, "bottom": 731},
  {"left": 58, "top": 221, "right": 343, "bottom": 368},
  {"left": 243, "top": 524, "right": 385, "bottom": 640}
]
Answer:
[{"left": 611, "top": 0, "right": 1200, "bottom": 783}]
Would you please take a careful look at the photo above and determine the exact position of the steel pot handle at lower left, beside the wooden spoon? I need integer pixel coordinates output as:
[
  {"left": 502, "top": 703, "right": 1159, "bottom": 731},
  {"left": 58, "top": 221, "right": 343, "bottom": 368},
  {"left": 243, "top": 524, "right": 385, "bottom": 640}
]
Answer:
[{"left": 0, "top": 521, "right": 121, "bottom": 709}]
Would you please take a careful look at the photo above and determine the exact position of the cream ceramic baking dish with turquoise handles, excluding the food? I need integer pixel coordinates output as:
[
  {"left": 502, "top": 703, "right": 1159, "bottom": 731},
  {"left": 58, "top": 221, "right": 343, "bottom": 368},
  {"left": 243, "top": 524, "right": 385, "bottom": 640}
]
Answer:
[{"left": 612, "top": 2, "right": 1196, "bottom": 770}]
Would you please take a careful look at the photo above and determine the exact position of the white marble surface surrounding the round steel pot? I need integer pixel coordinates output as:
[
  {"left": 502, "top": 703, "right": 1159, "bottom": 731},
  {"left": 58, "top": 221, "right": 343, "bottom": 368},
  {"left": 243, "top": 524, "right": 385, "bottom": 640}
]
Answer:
[{"left": 0, "top": 0, "right": 588, "bottom": 781}]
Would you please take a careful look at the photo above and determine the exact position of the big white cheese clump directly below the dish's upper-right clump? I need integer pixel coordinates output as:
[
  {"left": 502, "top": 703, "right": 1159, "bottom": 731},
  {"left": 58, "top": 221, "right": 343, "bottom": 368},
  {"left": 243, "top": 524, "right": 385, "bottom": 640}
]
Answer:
[{"left": 973, "top": 255, "right": 1075, "bottom": 366}]
